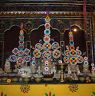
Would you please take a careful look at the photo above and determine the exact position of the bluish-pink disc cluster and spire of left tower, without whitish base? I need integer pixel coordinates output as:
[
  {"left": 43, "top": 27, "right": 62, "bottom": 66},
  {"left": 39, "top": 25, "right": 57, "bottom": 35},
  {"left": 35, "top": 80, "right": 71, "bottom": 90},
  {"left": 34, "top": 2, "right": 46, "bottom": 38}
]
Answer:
[{"left": 9, "top": 25, "right": 31, "bottom": 65}]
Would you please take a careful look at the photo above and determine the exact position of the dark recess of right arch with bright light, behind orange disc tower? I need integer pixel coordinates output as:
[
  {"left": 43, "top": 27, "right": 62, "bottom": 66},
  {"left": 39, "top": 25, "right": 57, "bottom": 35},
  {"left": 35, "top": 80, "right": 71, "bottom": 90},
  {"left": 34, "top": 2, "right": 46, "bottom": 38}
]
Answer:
[{"left": 64, "top": 25, "right": 86, "bottom": 52}]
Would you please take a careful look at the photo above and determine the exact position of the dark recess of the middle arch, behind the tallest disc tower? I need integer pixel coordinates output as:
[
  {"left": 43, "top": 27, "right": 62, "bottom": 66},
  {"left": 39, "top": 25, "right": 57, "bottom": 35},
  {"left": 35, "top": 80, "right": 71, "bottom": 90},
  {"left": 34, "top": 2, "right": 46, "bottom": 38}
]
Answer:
[{"left": 28, "top": 25, "right": 60, "bottom": 47}]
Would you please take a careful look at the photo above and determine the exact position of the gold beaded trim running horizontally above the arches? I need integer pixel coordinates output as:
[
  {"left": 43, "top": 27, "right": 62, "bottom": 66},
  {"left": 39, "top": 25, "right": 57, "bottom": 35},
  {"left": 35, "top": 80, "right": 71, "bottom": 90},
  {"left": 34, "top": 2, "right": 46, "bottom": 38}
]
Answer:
[{"left": 0, "top": 11, "right": 93, "bottom": 17}]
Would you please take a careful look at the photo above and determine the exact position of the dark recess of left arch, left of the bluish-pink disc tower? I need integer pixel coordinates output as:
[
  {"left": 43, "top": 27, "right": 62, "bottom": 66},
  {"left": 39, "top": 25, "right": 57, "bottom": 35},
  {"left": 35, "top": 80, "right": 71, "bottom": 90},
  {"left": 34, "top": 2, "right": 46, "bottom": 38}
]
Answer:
[{"left": 4, "top": 26, "right": 20, "bottom": 58}]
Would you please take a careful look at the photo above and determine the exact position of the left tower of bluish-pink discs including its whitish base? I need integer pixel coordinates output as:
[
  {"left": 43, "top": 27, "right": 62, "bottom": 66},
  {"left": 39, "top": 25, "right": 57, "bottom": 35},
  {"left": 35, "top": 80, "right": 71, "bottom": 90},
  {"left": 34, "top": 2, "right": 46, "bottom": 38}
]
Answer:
[{"left": 5, "top": 23, "right": 31, "bottom": 78}]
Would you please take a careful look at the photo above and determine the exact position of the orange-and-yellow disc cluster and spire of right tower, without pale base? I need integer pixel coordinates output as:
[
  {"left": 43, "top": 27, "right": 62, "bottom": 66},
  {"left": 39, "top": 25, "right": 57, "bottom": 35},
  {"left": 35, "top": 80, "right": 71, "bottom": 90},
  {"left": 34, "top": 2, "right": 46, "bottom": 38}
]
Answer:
[{"left": 64, "top": 32, "right": 83, "bottom": 65}]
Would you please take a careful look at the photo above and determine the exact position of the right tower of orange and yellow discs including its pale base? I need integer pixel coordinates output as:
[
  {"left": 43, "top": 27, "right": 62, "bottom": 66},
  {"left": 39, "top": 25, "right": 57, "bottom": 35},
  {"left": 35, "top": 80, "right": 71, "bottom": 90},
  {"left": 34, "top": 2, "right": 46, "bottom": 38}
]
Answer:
[{"left": 63, "top": 31, "right": 83, "bottom": 80}]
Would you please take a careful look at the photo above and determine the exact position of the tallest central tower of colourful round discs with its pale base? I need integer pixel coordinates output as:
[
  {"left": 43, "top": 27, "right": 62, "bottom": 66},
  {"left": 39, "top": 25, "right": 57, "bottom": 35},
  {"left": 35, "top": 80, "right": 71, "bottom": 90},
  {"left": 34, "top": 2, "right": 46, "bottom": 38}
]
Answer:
[{"left": 33, "top": 15, "right": 61, "bottom": 75}]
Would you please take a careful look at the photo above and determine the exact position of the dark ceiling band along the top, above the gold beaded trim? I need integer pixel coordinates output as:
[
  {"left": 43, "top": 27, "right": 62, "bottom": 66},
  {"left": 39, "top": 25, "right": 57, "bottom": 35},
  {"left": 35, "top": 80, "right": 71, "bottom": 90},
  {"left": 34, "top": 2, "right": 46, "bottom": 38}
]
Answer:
[{"left": 0, "top": 0, "right": 95, "bottom": 12}]
